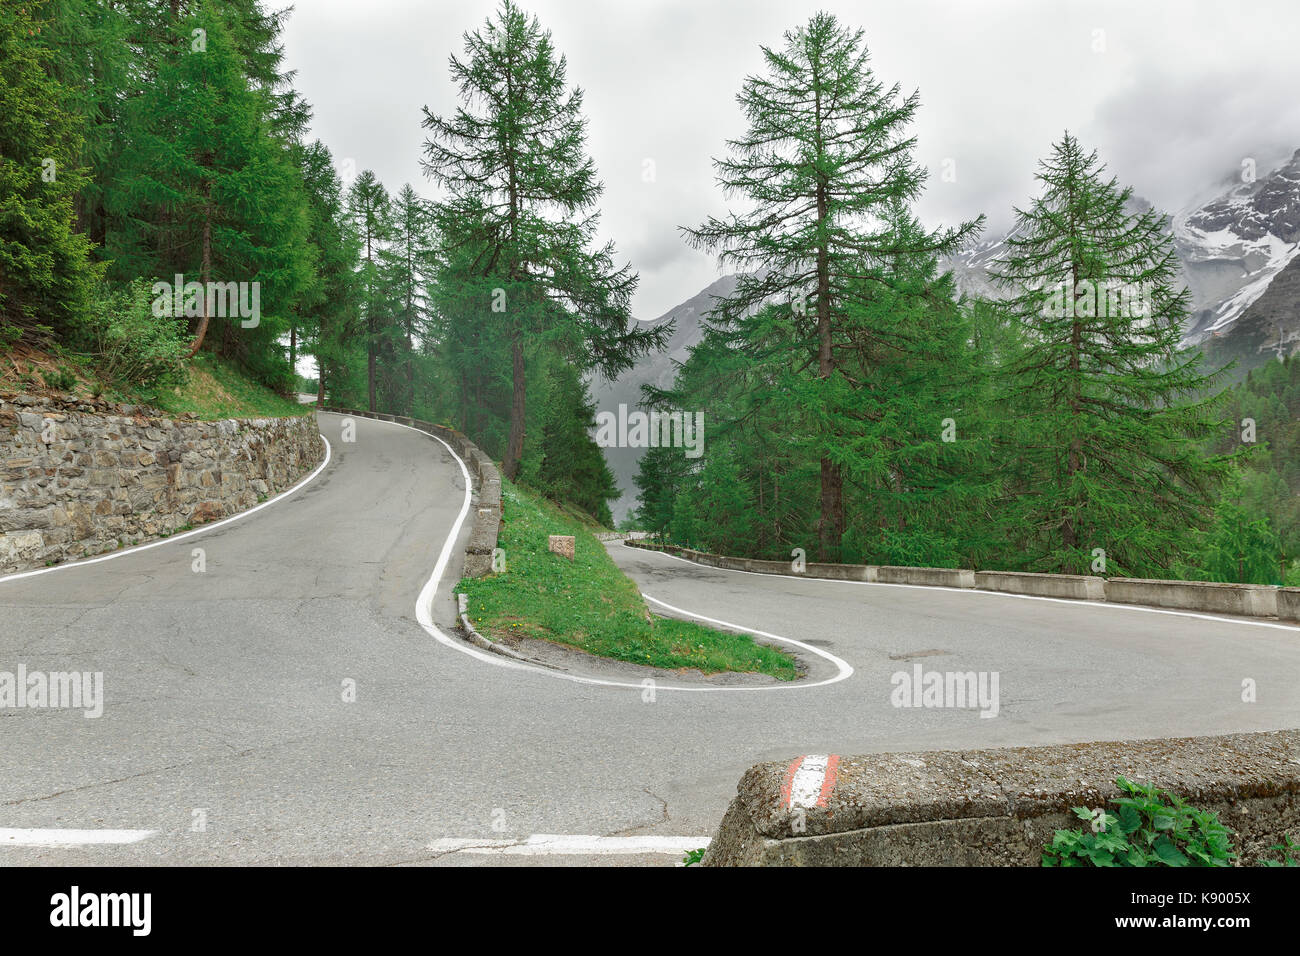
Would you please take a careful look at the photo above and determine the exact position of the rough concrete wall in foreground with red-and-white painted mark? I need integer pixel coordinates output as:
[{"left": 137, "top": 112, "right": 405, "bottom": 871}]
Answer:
[{"left": 702, "top": 731, "right": 1300, "bottom": 866}]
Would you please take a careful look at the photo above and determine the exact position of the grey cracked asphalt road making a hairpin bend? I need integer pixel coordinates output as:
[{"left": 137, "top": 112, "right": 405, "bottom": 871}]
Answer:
[{"left": 0, "top": 415, "right": 1300, "bottom": 865}]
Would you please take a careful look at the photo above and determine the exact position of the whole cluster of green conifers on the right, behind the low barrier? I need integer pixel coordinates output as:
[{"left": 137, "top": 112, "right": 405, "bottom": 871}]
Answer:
[{"left": 637, "top": 14, "right": 1300, "bottom": 584}]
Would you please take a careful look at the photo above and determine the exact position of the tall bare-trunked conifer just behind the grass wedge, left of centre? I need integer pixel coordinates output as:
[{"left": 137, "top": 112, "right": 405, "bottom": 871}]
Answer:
[{"left": 424, "top": 0, "right": 667, "bottom": 479}]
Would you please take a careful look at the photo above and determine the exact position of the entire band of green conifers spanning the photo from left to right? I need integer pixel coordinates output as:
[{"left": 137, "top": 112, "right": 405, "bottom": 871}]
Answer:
[{"left": 0, "top": 0, "right": 1300, "bottom": 574}]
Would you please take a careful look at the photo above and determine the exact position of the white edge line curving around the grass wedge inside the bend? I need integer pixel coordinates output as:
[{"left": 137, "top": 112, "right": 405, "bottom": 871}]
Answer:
[{"left": 329, "top": 412, "right": 853, "bottom": 693}]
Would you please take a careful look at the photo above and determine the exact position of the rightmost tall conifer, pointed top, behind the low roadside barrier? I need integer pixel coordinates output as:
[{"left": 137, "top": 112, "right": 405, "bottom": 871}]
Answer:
[{"left": 995, "top": 133, "right": 1232, "bottom": 575}]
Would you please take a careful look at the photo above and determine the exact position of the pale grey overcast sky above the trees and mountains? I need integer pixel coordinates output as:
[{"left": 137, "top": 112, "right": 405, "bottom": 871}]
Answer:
[{"left": 285, "top": 0, "right": 1300, "bottom": 319}]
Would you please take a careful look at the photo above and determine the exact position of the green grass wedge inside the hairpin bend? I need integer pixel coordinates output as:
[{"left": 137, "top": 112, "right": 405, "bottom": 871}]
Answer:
[{"left": 460, "top": 480, "right": 798, "bottom": 680}]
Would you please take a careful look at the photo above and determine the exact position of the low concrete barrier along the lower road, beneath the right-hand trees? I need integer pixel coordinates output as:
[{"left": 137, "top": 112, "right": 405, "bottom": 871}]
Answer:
[{"left": 624, "top": 540, "right": 1300, "bottom": 623}]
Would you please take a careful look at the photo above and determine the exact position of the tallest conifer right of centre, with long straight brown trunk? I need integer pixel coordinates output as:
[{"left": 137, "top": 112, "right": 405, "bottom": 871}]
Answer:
[{"left": 685, "top": 13, "right": 978, "bottom": 561}]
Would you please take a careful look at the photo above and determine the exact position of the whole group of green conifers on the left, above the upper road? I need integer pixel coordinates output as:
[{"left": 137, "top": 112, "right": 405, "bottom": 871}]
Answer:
[{"left": 0, "top": 0, "right": 629, "bottom": 522}]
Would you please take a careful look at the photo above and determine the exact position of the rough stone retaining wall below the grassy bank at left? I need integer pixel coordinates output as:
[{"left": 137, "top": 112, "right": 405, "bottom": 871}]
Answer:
[{"left": 0, "top": 395, "right": 325, "bottom": 574}]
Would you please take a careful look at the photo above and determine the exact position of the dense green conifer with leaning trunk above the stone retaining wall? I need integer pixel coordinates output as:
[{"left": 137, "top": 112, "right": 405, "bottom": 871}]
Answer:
[{"left": 107, "top": 0, "right": 313, "bottom": 366}]
